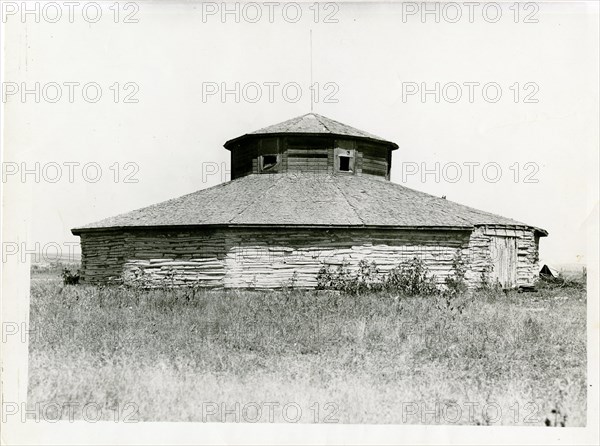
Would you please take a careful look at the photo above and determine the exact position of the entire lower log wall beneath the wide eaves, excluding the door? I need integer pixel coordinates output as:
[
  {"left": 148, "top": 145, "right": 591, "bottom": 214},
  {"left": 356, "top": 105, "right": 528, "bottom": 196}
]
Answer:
[{"left": 81, "top": 228, "right": 537, "bottom": 288}]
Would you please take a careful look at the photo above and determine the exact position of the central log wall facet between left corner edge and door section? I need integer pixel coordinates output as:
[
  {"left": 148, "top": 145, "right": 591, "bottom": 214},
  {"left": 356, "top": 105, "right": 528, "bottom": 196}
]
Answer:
[{"left": 225, "top": 230, "right": 468, "bottom": 288}]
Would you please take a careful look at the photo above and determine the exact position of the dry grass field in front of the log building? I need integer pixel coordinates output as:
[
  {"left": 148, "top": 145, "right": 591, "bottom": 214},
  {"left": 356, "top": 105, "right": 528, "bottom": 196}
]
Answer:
[{"left": 28, "top": 272, "right": 587, "bottom": 426}]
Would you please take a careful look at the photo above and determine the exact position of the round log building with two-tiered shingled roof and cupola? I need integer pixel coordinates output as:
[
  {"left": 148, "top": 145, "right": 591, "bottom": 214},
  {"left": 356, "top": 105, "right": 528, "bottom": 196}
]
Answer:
[{"left": 72, "top": 113, "right": 547, "bottom": 288}]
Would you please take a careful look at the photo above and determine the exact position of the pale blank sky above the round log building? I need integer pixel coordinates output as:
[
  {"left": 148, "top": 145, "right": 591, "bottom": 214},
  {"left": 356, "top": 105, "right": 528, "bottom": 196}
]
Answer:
[{"left": 2, "top": 2, "right": 600, "bottom": 264}]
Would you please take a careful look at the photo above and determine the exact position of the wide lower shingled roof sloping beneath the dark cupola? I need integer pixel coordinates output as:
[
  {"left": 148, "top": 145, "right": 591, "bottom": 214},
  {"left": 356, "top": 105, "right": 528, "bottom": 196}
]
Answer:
[{"left": 72, "top": 173, "right": 546, "bottom": 235}]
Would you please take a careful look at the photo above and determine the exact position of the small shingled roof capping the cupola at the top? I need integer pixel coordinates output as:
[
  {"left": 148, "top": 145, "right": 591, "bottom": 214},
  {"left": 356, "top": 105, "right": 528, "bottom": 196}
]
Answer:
[{"left": 224, "top": 113, "right": 398, "bottom": 150}]
